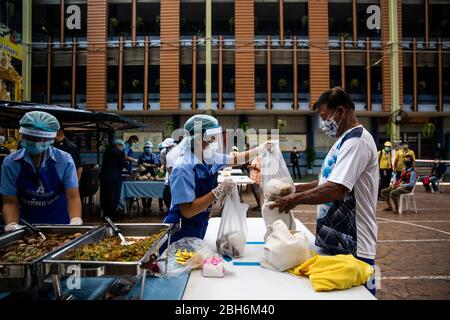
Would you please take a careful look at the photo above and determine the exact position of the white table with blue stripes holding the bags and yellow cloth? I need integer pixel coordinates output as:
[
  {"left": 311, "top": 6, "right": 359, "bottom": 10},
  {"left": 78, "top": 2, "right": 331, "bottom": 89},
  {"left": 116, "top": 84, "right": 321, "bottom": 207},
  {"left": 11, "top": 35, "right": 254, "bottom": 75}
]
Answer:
[{"left": 183, "top": 218, "right": 375, "bottom": 300}]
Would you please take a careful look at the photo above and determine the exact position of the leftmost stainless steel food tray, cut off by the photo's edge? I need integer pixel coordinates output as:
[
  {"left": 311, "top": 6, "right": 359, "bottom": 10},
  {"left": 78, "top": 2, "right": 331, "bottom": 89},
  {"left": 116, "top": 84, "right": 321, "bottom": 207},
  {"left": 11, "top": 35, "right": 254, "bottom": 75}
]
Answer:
[{"left": 0, "top": 225, "right": 98, "bottom": 292}]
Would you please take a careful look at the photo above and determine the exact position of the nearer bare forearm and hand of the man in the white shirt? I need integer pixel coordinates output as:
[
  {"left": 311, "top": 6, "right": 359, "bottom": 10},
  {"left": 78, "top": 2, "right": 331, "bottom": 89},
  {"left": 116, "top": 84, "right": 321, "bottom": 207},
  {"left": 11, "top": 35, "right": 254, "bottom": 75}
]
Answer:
[{"left": 270, "top": 181, "right": 348, "bottom": 212}]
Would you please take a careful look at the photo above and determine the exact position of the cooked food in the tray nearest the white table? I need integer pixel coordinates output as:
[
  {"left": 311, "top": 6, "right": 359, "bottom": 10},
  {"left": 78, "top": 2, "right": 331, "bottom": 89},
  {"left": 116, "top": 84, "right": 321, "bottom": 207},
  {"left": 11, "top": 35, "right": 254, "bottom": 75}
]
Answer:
[{"left": 64, "top": 230, "right": 164, "bottom": 262}]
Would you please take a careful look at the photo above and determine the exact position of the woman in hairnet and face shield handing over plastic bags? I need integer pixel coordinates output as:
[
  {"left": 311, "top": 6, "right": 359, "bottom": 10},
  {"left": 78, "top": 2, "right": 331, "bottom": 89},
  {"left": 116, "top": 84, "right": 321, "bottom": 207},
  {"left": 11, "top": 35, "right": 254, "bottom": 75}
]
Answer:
[{"left": 164, "top": 115, "right": 268, "bottom": 245}]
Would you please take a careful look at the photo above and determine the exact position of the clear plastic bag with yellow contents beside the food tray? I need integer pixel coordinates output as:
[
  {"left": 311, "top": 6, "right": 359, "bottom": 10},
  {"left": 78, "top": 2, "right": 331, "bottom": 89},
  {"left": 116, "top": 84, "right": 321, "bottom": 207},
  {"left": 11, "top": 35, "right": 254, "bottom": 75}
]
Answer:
[{"left": 158, "top": 237, "right": 214, "bottom": 278}]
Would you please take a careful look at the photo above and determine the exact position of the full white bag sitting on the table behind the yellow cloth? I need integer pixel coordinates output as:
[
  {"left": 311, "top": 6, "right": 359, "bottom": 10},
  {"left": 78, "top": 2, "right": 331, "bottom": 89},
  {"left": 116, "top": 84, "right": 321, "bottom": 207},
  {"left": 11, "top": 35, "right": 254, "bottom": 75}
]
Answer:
[{"left": 260, "top": 220, "right": 311, "bottom": 272}]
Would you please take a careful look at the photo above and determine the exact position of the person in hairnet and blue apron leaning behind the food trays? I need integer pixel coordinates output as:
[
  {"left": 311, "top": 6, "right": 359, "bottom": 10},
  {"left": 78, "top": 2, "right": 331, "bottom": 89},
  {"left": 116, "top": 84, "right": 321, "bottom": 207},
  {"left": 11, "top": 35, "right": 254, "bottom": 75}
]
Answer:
[{"left": 0, "top": 111, "right": 83, "bottom": 231}]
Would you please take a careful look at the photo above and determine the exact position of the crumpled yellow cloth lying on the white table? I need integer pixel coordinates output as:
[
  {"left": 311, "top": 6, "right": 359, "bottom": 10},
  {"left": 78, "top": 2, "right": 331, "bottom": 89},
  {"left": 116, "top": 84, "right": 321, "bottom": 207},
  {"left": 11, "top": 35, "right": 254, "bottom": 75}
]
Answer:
[{"left": 288, "top": 254, "right": 374, "bottom": 291}]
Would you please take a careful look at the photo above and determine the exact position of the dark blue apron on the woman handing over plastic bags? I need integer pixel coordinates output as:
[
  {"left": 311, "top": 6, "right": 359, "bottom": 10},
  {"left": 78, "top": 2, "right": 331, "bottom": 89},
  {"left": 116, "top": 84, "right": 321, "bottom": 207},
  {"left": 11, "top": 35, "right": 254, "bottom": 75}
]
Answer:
[{"left": 164, "top": 164, "right": 218, "bottom": 243}]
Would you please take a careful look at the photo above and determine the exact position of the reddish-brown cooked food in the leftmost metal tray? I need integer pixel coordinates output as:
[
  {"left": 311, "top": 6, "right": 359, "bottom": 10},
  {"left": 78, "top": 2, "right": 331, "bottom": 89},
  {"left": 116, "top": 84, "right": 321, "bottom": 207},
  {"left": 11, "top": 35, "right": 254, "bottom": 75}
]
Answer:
[{"left": 0, "top": 233, "right": 81, "bottom": 263}]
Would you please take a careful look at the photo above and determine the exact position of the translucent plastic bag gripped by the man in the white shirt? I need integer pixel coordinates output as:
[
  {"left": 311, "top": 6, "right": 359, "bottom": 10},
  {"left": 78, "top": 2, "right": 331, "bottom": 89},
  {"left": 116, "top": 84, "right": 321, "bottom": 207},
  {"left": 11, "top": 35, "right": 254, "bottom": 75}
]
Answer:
[{"left": 261, "top": 142, "right": 295, "bottom": 239}]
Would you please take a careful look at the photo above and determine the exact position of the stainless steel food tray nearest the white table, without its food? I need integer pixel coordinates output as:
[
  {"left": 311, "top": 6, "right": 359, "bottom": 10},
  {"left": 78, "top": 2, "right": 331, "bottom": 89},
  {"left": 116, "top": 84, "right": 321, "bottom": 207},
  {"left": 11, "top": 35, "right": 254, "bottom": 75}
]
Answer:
[{"left": 43, "top": 223, "right": 176, "bottom": 277}]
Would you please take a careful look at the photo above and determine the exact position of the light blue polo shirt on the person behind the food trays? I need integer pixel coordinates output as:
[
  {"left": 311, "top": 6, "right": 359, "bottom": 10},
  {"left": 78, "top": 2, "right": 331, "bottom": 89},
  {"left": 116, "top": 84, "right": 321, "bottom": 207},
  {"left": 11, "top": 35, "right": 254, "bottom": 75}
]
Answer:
[{"left": 0, "top": 147, "right": 78, "bottom": 196}]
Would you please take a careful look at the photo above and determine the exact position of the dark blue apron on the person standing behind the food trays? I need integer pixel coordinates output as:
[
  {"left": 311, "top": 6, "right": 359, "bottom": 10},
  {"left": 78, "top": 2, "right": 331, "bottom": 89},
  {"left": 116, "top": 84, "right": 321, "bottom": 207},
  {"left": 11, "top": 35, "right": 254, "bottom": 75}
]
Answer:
[{"left": 16, "top": 159, "right": 70, "bottom": 224}]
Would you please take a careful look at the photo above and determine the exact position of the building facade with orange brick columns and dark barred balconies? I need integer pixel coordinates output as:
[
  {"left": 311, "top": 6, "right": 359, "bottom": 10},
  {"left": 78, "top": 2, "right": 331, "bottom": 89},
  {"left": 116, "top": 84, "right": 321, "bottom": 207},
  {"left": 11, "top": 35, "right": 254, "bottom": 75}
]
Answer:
[{"left": 7, "top": 0, "right": 450, "bottom": 158}]
